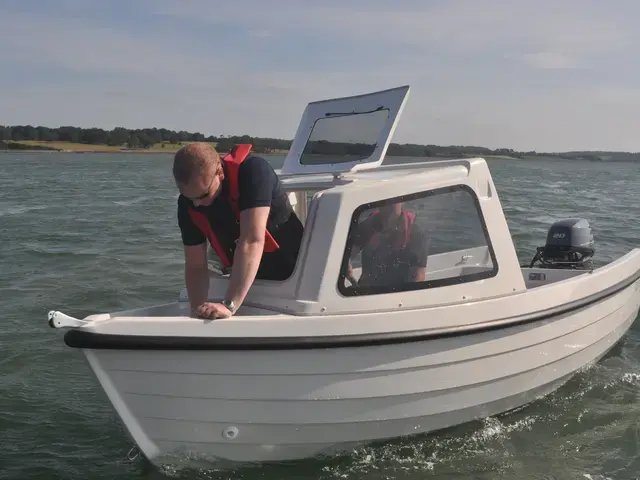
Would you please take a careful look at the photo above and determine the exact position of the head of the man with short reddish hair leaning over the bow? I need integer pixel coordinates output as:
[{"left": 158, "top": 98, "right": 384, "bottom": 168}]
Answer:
[{"left": 173, "top": 143, "right": 224, "bottom": 206}]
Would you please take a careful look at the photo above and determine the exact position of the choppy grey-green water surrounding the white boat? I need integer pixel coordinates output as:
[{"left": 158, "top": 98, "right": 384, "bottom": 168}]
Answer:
[{"left": 0, "top": 153, "right": 640, "bottom": 480}]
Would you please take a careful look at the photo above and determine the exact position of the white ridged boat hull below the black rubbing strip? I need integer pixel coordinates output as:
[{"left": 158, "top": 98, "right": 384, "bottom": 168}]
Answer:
[{"left": 77, "top": 281, "right": 640, "bottom": 464}]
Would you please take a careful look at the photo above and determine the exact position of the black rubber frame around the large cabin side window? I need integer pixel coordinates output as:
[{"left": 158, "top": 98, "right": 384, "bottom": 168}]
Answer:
[{"left": 337, "top": 184, "right": 500, "bottom": 297}]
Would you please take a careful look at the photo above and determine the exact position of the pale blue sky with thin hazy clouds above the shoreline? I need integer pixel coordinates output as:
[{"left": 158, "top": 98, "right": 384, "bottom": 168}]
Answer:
[{"left": 0, "top": 0, "right": 640, "bottom": 152}]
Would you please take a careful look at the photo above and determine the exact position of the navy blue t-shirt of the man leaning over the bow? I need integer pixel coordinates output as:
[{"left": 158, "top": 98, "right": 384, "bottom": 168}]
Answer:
[{"left": 178, "top": 156, "right": 303, "bottom": 280}]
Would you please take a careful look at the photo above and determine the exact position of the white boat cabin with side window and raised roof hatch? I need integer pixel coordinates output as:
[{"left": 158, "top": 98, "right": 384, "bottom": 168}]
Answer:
[{"left": 181, "top": 86, "right": 526, "bottom": 315}]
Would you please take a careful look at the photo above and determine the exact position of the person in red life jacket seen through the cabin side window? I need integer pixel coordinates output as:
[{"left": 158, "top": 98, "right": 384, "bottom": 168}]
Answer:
[{"left": 347, "top": 203, "right": 427, "bottom": 286}]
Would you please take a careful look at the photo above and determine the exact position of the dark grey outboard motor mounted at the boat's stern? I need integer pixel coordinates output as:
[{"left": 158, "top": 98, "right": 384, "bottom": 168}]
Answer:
[{"left": 529, "top": 218, "right": 595, "bottom": 270}]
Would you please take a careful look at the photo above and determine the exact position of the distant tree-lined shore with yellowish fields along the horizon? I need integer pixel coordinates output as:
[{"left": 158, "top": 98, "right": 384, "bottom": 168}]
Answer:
[{"left": 0, "top": 125, "right": 640, "bottom": 162}]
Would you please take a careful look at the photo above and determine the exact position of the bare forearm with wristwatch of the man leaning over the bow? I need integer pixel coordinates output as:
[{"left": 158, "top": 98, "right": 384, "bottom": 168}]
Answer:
[{"left": 225, "top": 207, "right": 271, "bottom": 307}]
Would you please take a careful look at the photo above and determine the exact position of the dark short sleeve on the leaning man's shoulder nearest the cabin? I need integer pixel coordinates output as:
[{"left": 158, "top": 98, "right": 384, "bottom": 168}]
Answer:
[{"left": 238, "top": 156, "right": 278, "bottom": 211}]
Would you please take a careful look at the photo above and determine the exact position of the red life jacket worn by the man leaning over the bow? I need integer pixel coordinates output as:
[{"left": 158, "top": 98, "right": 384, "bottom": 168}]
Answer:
[{"left": 188, "top": 143, "right": 280, "bottom": 267}]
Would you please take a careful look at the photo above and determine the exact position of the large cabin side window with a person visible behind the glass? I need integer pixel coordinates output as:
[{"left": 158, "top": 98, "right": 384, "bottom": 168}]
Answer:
[{"left": 338, "top": 185, "right": 498, "bottom": 296}]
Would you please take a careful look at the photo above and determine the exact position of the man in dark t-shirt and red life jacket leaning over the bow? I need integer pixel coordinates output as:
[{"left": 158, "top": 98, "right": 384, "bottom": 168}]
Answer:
[{"left": 173, "top": 143, "right": 303, "bottom": 318}]
